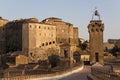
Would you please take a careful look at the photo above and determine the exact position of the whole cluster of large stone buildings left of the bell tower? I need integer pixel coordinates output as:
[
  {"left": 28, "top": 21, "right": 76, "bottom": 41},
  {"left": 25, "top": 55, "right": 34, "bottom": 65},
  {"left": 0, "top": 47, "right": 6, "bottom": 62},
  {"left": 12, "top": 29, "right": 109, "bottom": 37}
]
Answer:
[{"left": 0, "top": 17, "right": 79, "bottom": 64}]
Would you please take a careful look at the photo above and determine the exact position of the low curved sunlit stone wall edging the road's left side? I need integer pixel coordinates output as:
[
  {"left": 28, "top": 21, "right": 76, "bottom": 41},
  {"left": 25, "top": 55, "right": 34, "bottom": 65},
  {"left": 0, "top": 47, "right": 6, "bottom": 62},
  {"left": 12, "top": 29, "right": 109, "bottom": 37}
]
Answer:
[{"left": 0, "top": 65, "right": 84, "bottom": 80}]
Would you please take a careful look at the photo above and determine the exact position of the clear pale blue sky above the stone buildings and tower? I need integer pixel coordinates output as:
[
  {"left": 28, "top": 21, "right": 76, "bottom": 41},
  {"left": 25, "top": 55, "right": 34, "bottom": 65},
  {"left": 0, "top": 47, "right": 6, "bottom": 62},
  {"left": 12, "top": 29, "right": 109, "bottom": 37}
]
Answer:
[{"left": 0, "top": 0, "right": 120, "bottom": 41}]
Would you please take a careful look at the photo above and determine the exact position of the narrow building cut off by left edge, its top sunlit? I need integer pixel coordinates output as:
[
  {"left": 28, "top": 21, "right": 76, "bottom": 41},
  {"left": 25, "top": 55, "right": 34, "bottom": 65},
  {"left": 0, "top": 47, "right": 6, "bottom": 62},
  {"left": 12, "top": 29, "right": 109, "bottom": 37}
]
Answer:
[{"left": 0, "top": 17, "right": 8, "bottom": 53}]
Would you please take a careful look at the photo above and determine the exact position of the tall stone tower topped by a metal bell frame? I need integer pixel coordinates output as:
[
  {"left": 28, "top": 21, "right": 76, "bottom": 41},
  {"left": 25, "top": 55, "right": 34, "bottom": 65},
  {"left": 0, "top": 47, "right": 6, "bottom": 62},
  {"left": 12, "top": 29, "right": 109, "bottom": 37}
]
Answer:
[{"left": 88, "top": 10, "right": 104, "bottom": 64}]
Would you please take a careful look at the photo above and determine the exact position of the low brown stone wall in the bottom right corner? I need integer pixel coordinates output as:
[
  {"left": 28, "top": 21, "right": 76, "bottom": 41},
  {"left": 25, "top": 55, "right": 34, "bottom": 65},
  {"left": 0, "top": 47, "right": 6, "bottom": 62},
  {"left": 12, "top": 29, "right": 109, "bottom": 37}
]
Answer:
[{"left": 88, "top": 67, "right": 120, "bottom": 80}]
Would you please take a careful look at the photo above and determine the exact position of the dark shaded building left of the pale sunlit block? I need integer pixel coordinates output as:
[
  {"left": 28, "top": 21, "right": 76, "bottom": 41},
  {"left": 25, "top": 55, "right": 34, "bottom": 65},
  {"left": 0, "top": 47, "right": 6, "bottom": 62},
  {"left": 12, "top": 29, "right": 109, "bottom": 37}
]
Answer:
[{"left": 5, "top": 18, "right": 38, "bottom": 53}]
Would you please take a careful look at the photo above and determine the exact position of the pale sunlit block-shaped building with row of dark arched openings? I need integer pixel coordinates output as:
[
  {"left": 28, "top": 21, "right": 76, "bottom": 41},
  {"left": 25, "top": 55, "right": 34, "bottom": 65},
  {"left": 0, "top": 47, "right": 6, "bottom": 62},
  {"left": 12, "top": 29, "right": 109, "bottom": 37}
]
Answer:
[{"left": 22, "top": 22, "right": 56, "bottom": 62}]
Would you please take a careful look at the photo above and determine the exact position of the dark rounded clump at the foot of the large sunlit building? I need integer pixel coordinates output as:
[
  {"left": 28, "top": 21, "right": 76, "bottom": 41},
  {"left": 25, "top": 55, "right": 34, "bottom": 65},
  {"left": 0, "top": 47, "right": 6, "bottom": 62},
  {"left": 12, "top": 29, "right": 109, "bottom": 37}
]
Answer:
[{"left": 48, "top": 54, "right": 60, "bottom": 68}]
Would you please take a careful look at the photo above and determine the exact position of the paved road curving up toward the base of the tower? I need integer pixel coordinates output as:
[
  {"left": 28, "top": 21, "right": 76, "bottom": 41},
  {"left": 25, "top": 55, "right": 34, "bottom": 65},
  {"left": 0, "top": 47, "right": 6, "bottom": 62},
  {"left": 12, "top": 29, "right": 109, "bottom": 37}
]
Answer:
[{"left": 60, "top": 66, "right": 91, "bottom": 80}]
